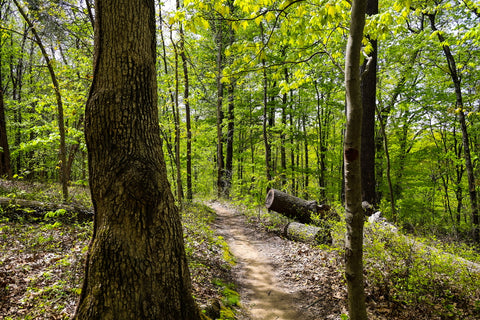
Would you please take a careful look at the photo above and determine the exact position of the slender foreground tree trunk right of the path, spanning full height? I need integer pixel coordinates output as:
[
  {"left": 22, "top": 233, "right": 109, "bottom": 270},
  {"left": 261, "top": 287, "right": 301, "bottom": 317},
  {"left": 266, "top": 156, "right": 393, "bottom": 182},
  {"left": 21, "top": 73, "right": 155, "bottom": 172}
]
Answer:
[{"left": 344, "top": 0, "right": 367, "bottom": 320}]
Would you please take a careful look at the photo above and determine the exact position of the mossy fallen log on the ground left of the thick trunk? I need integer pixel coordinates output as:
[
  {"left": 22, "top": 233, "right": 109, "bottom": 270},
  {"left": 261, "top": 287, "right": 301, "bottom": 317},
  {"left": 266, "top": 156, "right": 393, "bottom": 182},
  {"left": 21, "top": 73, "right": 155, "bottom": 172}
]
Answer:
[{"left": 0, "top": 197, "right": 93, "bottom": 222}]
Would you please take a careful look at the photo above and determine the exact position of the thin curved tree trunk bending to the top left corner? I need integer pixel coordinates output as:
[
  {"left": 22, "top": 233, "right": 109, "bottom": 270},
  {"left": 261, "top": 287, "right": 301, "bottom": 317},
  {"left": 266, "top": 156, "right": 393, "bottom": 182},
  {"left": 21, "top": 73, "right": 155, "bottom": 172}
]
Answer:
[{"left": 13, "top": 0, "right": 68, "bottom": 201}]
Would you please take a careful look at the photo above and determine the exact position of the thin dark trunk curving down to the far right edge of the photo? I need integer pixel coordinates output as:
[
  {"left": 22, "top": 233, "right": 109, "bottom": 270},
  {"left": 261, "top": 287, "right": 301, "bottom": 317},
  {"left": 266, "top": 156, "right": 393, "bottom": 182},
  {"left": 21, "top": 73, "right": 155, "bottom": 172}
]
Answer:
[{"left": 428, "top": 14, "right": 480, "bottom": 243}]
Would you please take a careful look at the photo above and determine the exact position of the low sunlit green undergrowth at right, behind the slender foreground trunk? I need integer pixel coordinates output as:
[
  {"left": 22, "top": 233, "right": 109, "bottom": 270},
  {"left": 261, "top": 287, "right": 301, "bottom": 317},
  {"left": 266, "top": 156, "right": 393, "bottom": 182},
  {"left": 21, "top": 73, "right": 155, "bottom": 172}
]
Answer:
[{"left": 333, "top": 207, "right": 480, "bottom": 320}]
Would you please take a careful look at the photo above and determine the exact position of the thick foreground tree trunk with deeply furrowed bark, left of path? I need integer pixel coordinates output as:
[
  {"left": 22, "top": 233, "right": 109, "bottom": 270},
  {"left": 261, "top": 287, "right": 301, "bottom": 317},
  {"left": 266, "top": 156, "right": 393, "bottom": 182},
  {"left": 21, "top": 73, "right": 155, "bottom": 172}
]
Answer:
[{"left": 74, "top": 0, "right": 200, "bottom": 320}]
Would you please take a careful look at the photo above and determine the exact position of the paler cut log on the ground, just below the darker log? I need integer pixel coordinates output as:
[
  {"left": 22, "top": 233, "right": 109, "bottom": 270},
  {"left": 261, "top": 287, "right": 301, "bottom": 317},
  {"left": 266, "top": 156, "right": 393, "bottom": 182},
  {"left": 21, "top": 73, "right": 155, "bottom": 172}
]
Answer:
[{"left": 283, "top": 222, "right": 332, "bottom": 245}]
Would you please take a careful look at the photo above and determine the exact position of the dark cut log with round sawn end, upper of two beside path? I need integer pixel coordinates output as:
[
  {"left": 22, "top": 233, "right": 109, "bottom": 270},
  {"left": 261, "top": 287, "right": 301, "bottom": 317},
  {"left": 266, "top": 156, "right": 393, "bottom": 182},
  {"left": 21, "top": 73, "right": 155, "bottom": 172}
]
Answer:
[{"left": 265, "top": 189, "right": 318, "bottom": 223}]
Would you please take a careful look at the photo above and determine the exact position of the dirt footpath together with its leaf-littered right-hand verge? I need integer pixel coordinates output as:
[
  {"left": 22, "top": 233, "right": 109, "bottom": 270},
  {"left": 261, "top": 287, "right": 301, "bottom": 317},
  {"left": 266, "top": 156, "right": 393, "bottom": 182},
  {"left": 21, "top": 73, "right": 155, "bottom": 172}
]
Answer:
[{"left": 210, "top": 202, "right": 344, "bottom": 320}]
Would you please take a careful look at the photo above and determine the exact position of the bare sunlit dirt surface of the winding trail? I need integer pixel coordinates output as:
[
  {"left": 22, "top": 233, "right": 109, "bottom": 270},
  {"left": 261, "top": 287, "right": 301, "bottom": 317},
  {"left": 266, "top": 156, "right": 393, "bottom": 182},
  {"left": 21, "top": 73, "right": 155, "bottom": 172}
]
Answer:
[{"left": 211, "top": 203, "right": 324, "bottom": 320}]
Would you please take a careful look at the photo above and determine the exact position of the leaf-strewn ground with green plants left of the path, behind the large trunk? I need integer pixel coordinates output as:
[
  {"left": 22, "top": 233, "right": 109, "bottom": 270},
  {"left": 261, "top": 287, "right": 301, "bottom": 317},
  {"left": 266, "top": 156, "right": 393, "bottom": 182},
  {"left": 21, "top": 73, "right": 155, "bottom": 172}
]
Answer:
[{"left": 0, "top": 182, "right": 239, "bottom": 320}]
